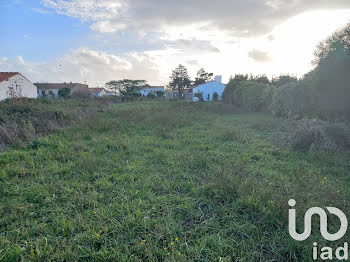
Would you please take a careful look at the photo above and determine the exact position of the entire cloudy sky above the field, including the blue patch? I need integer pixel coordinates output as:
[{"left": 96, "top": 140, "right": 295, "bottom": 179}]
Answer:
[{"left": 0, "top": 0, "right": 350, "bottom": 87}]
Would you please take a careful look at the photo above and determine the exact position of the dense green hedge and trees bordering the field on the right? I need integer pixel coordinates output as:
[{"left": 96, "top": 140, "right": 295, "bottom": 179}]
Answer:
[{"left": 223, "top": 24, "right": 350, "bottom": 121}]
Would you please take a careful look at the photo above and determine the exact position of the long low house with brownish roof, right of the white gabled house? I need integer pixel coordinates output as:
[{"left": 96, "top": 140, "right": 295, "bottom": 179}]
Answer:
[{"left": 35, "top": 83, "right": 91, "bottom": 98}]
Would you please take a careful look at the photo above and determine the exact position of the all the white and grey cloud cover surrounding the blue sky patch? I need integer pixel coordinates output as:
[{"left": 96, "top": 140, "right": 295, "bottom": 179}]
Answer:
[{"left": 4, "top": 0, "right": 350, "bottom": 86}]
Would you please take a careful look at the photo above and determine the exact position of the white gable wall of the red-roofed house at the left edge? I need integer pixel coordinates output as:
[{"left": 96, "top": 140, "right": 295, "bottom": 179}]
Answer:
[{"left": 0, "top": 74, "right": 38, "bottom": 101}]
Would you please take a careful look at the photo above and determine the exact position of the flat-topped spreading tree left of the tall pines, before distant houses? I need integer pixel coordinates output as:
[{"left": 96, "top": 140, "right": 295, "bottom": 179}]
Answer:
[{"left": 106, "top": 79, "right": 148, "bottom": 97}]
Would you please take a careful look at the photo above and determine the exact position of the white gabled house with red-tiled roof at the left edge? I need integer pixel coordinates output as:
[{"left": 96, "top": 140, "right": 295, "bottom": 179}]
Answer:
[{"left": 0, "top": 72, "right": 38, "bottom": 101}]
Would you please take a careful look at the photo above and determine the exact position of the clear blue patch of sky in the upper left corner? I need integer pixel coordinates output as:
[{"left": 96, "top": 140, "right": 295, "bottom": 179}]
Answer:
[{"left": 0, "top": 0, "right": 90, "bottom": 61}]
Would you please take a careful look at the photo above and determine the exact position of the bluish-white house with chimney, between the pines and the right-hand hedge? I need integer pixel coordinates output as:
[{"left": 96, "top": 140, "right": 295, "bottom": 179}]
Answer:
[{"left": 192, "top": 76, "right": 226, "bottom": 101}]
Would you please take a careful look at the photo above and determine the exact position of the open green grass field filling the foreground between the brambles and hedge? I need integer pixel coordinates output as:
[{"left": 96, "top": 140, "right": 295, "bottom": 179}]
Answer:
[{"left": 0, "top": 102, "right": 350, "bottom": 261}]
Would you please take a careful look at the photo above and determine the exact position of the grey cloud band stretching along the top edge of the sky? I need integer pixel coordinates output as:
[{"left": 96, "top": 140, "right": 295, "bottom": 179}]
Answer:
[{"left": 42, "top": 0, "right": 350, "bottom": 36}]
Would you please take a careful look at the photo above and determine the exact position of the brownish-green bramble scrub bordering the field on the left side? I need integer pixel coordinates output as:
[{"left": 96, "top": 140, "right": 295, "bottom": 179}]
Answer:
[{"left": 0, "top": 98, "right": 106, "bottom": 151}]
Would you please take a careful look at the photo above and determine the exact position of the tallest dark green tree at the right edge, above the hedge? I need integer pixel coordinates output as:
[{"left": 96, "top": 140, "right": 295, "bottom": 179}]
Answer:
[{"left": 313, "top": 24, "right": 350, "bottom": 119}]
